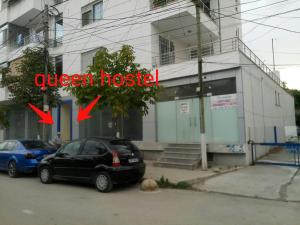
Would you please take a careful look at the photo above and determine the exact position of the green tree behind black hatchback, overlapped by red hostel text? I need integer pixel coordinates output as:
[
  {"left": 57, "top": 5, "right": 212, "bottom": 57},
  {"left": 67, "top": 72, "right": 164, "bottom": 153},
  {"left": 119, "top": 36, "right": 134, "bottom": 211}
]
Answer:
[{"left": 66, "top": 45, "right": 160, "bottom": 136}]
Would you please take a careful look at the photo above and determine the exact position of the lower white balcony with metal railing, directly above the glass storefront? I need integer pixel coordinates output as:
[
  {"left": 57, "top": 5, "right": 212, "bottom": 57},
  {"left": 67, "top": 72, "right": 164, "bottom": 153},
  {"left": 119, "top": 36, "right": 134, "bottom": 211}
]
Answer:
[{"left": 152, "top": 38, "right": 283, "bottom": 87}]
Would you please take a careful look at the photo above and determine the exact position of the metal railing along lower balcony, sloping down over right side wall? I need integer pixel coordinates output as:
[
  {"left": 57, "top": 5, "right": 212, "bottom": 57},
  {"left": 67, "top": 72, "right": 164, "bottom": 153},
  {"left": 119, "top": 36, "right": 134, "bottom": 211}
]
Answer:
[{"left": 153, "top": 38, "right": 284, "bottom": 87}]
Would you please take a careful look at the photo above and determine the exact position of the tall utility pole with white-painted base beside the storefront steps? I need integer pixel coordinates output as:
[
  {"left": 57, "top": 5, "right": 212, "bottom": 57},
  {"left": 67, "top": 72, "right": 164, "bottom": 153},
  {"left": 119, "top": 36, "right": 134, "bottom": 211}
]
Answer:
[{"left": 193, "top": 0, "right": 207, "bottom": 170}]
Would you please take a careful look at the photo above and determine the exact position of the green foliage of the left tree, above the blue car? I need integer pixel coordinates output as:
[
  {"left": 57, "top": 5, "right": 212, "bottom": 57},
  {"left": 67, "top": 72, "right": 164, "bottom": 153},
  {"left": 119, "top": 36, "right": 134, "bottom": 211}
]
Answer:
[{"left": 1, "top": 48, "right": 60, "bottom": 108}]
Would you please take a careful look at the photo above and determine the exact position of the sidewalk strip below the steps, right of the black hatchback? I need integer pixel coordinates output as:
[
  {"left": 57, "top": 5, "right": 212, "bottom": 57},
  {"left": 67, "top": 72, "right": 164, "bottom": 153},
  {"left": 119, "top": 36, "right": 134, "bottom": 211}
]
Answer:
[{"left": 144, "top": 160, "right": 238, "bottom": 184}]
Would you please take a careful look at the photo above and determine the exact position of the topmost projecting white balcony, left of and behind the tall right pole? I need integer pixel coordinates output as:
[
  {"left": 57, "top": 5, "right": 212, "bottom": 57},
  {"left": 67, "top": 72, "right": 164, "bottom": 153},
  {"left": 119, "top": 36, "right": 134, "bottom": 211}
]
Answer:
[{"left": 151, "top": 0, "right": 219, "bottom": 52}]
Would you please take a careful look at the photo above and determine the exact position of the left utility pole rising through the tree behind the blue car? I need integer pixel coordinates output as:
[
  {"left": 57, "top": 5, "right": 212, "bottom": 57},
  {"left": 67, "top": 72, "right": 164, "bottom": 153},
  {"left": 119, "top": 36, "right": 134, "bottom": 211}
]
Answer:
[{"left": 43, "top": 4, "right": 49, "bottom": 141}]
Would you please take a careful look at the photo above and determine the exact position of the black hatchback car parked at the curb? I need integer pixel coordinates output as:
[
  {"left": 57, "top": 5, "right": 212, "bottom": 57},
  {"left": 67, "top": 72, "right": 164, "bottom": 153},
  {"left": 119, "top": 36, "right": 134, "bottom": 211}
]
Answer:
[{"left": 38, "top": 138, "right": 145, "bottom": 192}]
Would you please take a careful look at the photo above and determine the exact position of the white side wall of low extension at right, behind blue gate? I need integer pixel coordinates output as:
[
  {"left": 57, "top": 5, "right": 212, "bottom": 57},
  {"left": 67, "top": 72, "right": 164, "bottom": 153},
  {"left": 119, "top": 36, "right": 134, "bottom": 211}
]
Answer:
[{"left": 240, "top": 54, "right": 296, "bottom": 160}]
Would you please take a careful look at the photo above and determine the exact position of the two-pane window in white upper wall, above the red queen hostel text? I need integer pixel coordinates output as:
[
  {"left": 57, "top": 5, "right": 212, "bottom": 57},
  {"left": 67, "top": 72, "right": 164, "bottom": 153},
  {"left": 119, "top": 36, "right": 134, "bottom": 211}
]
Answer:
[{"left": 81, "top": 1, "right": 103, "bottom": 26}]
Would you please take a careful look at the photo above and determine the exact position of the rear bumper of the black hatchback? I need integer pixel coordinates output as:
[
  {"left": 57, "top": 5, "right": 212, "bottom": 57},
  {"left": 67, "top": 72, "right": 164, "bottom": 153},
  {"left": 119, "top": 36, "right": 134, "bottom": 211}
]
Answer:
[{"left": 109, "top": 163, "right": 146, "bottom": 184}]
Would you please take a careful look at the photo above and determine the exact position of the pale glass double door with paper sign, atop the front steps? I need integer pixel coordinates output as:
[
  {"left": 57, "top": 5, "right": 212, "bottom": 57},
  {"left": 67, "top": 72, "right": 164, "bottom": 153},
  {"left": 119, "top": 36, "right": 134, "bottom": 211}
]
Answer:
[{"left": 176, "top": 99, "right": 200, "bottom": 143}]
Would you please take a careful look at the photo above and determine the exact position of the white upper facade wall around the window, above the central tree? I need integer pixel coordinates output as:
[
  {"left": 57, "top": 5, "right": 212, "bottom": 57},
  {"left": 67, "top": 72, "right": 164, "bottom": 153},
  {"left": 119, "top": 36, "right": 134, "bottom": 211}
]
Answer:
[{"left": 53, "top": 0, "right": 152, "bottom": 74}]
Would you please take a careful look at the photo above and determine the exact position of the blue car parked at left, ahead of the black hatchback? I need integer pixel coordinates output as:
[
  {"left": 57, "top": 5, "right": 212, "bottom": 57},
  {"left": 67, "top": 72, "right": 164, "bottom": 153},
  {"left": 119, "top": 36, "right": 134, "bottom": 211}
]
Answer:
[{"left": 0, "top": 140, "right": 56, "bottom": 177}]
